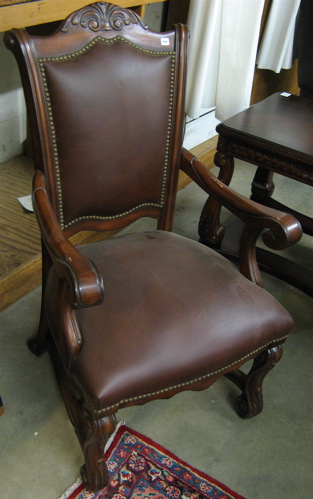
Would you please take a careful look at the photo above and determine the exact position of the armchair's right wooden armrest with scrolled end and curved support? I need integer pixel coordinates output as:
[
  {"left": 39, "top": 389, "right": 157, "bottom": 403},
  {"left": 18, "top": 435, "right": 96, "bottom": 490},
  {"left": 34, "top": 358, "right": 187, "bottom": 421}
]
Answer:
[{"left": 180, "top": 149, "right": 302, "bottom": 284}]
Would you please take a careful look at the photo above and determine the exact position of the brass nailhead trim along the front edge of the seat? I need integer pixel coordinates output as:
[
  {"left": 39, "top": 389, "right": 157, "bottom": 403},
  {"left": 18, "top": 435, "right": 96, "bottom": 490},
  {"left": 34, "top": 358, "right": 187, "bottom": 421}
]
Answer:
[{"left": 70, "top": 336, "right": 287, "bottom": 416}]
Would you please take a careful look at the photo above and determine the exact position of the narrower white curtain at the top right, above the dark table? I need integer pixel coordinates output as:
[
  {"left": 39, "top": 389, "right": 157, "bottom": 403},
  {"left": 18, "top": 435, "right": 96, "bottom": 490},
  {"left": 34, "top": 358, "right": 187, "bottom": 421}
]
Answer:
[{"left": 257, "top": 0, "right": 300, "bottom": 73}]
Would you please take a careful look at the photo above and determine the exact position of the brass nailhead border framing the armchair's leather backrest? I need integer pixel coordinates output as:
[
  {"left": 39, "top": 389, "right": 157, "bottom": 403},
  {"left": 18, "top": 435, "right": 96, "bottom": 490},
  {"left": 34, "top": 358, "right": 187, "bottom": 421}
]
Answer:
[{"left": 38, "top": 36, "right": 175, "bottom": 229}]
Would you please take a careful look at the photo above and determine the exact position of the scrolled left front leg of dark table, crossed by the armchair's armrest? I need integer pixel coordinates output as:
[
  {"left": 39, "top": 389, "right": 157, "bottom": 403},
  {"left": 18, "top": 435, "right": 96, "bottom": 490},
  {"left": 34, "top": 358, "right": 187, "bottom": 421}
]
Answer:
[{"left": 199, "top": 151, "right": 234, "bottom": 247}]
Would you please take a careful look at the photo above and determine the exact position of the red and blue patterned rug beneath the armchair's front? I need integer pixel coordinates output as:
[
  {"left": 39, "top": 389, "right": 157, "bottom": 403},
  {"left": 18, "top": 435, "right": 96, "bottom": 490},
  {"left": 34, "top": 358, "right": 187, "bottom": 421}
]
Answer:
[{"left": 59, "top": 425, "right": 244, "bottom": 499}]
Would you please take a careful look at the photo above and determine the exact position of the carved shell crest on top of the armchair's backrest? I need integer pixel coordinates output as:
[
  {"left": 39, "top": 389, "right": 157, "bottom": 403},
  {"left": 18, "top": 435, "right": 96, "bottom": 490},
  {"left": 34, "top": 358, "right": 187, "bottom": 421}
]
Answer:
[{"left": 61, "top": 2, "right": 148, "bottom": 33}]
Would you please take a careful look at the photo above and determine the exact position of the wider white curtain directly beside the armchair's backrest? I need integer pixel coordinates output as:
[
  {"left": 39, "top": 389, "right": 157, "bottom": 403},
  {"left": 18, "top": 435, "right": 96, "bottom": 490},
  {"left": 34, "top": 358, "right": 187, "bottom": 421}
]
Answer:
[{"left": 186, "top": 0, "right": 265, "bottom": 120}]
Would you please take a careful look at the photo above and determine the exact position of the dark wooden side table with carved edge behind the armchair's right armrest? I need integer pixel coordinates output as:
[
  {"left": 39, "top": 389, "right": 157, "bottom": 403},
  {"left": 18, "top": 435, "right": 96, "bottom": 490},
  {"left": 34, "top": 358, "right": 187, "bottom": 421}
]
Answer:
[{"left": 199, "top": 93, "right": 313, "bottom": 296}]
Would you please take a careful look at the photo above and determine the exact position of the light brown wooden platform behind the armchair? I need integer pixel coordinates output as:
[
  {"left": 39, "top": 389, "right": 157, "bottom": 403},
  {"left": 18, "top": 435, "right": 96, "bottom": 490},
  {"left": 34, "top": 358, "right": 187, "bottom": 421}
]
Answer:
[{"left": 0, "top": 137, "right": 216, "bottom": 311}]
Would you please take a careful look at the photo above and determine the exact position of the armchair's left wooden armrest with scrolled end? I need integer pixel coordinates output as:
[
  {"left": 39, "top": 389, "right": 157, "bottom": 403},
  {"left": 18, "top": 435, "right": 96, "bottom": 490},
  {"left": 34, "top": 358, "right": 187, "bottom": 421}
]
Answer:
[{"left": 33, "top": 170, "right": 104, "bottom": 308}]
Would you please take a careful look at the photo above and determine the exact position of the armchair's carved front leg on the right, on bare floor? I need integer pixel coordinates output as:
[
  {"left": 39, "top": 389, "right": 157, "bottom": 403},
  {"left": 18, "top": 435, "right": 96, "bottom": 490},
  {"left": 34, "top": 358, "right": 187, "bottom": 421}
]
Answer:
[{"left": 225, "top": 345, "right": 283, "bottom": 419}]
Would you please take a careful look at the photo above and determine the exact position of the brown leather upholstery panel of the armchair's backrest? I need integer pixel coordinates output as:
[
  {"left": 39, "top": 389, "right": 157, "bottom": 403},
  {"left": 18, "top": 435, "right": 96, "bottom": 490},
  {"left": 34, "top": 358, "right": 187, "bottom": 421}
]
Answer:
[{"left": 44, "top": 40, "right": 173, "bottom": 226}]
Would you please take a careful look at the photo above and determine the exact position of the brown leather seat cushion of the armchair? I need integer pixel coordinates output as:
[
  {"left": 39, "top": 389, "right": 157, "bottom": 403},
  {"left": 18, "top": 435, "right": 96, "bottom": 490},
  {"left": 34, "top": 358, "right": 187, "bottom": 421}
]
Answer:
[{"left": 46, "top": 231, "right": 293, "bottom": 410}]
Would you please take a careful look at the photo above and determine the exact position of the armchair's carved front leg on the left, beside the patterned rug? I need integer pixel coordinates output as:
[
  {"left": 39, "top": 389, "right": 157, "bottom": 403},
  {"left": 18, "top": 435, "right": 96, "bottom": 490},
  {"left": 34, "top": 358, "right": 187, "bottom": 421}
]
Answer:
[{"left": 80, "top": 409, "right": 116, "bottom": 492}]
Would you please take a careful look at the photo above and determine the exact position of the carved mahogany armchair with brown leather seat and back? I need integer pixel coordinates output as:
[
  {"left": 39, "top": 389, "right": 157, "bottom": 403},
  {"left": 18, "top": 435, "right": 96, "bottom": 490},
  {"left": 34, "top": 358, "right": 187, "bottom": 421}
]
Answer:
[{"left": 5, "top": 2, "right": 301, "bottom": 490}]
